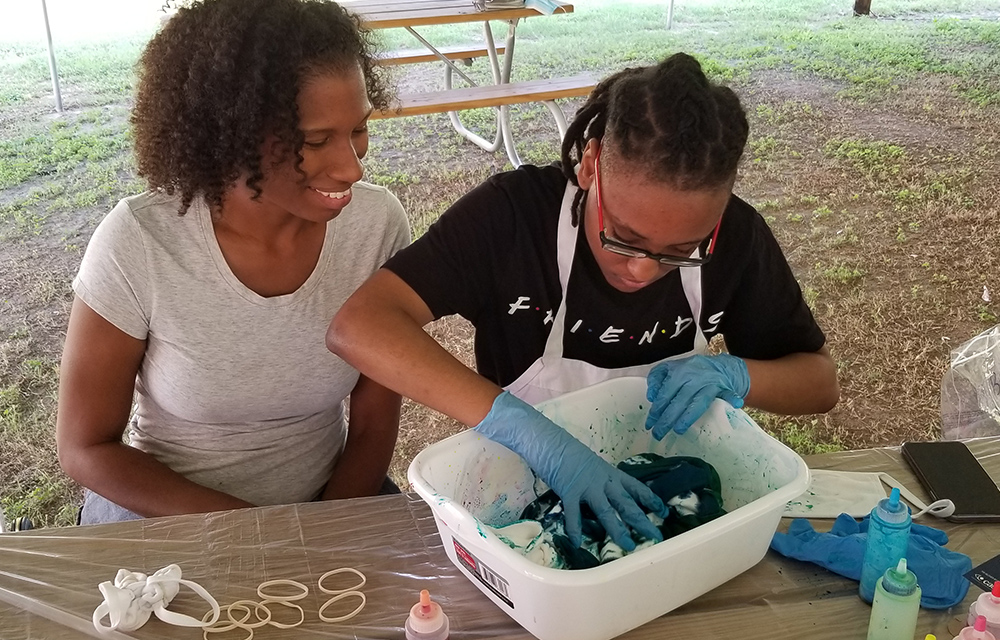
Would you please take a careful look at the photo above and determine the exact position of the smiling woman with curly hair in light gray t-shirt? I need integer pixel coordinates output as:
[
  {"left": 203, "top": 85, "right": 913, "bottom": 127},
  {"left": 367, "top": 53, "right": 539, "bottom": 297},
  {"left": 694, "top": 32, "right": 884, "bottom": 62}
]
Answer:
[{"left": 57, "top": 0, "right": 409, "bottom": 524}]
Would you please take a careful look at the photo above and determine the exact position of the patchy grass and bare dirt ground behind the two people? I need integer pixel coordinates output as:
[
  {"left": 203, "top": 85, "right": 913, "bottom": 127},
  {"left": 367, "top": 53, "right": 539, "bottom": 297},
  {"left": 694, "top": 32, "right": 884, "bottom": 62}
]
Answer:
[{"left": 0, "top": 0, "right": 1000, "bottom": 525}]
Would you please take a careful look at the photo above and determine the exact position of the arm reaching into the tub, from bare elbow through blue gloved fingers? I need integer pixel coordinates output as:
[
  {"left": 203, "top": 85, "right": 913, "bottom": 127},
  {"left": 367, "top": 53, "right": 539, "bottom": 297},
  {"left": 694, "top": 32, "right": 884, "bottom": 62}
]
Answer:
[{"left": 326, "top": 269, "right": 663, "bottom": 549}]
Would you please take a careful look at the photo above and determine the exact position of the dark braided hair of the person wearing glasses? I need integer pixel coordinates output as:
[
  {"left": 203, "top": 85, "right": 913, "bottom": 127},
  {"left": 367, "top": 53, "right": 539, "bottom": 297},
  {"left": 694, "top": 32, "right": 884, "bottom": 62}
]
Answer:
[{"left": 562, "top": 53, "right": 750, "bottom": 224}]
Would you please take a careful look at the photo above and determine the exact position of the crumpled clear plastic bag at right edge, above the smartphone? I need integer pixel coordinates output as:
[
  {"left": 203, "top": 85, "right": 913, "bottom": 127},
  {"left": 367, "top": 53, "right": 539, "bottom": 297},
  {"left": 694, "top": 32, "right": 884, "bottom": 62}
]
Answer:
[{"left": 941, "top": 325, "right": 1000, "bottom": 440}]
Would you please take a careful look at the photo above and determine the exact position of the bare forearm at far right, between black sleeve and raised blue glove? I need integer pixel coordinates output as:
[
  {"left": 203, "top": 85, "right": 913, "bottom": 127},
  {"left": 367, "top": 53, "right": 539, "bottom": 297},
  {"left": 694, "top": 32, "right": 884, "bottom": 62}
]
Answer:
[{"left": 744, "top": 345, "right": 840, "bottom": 415}]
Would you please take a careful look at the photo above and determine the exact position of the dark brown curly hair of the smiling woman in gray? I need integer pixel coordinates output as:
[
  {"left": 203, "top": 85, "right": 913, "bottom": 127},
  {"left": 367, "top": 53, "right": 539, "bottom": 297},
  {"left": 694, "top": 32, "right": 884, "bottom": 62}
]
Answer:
[{"left": 131, "top": 0, "right": 390, "bottom": 214}]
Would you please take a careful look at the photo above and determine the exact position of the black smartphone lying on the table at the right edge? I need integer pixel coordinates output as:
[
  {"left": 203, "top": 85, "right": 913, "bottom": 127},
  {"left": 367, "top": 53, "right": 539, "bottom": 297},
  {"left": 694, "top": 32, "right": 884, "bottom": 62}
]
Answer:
[{"left": 902, "top": 440, "right": 1000, "bottom": 522}]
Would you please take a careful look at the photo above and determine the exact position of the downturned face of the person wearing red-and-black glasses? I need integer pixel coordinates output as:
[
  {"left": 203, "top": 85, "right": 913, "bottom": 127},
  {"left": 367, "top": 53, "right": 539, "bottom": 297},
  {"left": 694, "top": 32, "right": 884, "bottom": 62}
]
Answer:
[{"left": 577, "top": 139, "right": 732, "bottom": 293}]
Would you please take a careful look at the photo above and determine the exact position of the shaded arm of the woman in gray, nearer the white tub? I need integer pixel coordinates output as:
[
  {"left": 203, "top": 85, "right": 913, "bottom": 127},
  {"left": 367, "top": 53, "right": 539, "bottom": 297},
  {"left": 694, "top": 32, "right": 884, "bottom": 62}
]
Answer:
[{"left": 323, "top": 375, "right": 400, "bottom": 500}]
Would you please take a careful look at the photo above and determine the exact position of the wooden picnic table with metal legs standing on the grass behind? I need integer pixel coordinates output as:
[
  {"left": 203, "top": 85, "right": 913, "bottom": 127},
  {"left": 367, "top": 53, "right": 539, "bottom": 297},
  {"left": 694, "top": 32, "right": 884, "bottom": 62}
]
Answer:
[{"left": 341, "top": 0, "right": 596, "bottom": 167}]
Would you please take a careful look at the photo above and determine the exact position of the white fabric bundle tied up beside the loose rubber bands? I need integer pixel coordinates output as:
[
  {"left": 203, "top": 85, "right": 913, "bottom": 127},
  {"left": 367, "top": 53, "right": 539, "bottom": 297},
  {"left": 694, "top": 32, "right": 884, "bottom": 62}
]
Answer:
[{"left": 93, "top": 564, "right": 220, "bottom": 633}]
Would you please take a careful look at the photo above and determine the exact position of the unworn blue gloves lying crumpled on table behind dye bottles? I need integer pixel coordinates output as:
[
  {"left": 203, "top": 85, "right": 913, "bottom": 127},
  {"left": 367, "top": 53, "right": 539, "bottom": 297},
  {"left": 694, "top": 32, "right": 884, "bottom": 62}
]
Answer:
[{"left": 771, "top": 513, "right": 972, "bottom": 609}]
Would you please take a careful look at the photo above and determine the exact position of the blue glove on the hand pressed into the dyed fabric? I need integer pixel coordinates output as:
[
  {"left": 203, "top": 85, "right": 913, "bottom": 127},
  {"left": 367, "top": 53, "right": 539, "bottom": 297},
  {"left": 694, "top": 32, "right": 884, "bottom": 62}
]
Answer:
[{"left": 476, "top": 391, "right": 667, "bottom": 551}]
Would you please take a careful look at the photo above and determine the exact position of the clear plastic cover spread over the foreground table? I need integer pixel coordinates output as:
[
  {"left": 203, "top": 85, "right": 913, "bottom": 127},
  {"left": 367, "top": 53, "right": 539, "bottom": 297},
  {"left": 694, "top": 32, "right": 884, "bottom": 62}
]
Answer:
[{"left": 0, "top": 437, "right": 1000, "bottom": 640}]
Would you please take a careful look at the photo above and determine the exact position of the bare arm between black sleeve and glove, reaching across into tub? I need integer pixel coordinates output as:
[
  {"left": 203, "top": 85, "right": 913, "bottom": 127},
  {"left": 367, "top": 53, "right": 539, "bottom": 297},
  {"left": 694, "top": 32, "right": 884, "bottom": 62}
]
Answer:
[{"left": 326, "top": 269, "right": 501, "bottom": 426}]
